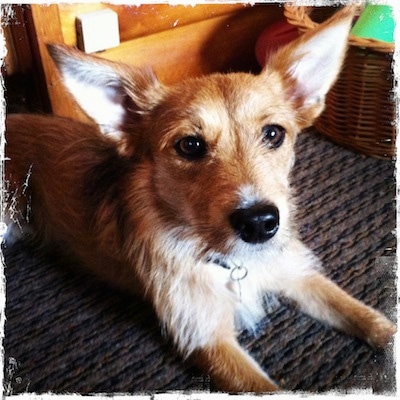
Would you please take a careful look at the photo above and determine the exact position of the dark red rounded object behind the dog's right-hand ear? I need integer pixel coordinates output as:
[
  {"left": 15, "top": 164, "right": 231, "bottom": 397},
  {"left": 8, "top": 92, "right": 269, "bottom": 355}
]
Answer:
[{"left": 255, "top": 20, "right": 299, "bottom": 67}]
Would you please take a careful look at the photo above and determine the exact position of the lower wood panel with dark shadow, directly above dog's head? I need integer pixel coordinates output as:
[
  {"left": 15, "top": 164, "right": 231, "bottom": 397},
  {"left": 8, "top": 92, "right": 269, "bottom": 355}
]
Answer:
[{"left": 98, "top": 6, "right": 281, "bottom": 83}]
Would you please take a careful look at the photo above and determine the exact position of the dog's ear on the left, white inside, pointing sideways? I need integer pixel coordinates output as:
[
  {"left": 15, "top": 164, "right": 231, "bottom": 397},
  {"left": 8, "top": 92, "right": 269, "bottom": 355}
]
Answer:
[{"left": 47, "top": 45, "right": 162, "bottom": 137}]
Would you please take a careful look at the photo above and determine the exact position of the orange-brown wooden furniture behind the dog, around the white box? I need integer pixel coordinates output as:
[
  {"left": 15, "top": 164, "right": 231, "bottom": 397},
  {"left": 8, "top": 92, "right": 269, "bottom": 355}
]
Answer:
[{"left": 7, "top": 3, "right": 283, "bottom": 119}]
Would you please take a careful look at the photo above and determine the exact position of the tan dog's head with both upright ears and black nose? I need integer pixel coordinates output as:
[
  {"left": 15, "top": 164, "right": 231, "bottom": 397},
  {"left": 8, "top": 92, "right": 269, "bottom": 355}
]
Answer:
[{"left": 49, "top": 8, "right": 352, "bottom": 262}]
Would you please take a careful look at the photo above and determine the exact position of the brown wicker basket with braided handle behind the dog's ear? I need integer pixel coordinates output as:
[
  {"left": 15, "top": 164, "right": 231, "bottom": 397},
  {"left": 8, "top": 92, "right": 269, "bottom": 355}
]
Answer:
[{"left": 285, "top": 5, "right": 396, "bottom": 159}]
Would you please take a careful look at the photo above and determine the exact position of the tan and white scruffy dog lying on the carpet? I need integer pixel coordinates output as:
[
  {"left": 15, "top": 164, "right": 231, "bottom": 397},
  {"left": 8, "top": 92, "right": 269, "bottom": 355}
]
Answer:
[{"left": 6, "top": 7, "right": 396, "bottom": 392}]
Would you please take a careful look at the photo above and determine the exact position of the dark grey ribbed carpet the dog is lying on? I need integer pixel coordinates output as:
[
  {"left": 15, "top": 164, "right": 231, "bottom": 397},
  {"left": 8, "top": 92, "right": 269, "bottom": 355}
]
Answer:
[{"left": 3, "top": 130, "right": 396, "bottom": 394}]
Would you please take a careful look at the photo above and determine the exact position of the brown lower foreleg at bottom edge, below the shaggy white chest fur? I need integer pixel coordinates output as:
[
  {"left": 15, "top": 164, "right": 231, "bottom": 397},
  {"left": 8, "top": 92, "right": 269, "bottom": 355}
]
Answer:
[{"left": 193, "top": 337, "right": 279, "bottom": 393}]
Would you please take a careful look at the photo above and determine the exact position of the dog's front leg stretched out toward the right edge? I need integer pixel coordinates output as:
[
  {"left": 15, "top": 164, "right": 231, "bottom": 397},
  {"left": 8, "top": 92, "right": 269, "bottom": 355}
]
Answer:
[{"left": 282, "top": 272, "right": 396, "bottom": 347}]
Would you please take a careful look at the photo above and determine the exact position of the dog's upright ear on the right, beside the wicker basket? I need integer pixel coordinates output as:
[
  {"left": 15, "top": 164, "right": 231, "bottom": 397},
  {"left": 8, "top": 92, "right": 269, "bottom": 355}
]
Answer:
[{"left": 264, "top": 6, "right": 355, "bottom": 128}]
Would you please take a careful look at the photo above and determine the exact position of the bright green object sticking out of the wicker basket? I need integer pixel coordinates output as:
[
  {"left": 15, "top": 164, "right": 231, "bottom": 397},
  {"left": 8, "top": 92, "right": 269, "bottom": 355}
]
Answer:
[{"left": 351, "top": 4, "right": 395, "bottom": 43}]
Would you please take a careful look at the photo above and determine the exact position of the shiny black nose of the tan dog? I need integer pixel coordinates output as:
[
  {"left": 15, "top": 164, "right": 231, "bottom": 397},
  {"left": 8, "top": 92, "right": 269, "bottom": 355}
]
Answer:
[{"left": 229, "top": 204, "right": 279, "bottom": 244}]
